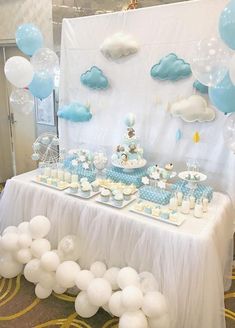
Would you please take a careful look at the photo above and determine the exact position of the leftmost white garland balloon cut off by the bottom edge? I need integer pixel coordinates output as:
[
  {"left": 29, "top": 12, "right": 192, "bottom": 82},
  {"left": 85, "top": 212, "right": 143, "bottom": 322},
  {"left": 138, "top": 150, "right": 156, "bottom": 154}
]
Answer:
[{"left": 118, "top": 311, "right": 148, "bottom": 328}]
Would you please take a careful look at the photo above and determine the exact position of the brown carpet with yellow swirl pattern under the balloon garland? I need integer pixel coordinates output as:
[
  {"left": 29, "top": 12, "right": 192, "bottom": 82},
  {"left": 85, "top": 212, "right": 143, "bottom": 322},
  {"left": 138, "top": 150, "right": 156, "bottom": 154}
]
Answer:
[{"left": 0, "top": 269, "right": 235, "bottom": 328}]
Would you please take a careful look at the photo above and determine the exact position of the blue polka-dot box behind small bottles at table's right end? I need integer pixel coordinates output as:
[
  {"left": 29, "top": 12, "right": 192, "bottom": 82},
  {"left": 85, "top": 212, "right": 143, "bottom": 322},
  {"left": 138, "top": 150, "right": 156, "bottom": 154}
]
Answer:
[{"left": 172, "top": 180, "right": 213, "bottom": 201}]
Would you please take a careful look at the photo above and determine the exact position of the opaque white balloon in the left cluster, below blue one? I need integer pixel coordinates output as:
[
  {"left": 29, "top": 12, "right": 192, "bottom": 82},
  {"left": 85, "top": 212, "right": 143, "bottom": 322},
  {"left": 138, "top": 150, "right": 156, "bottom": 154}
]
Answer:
[{"left": 4, "top": 56, "right": 34, "bottom": 88}]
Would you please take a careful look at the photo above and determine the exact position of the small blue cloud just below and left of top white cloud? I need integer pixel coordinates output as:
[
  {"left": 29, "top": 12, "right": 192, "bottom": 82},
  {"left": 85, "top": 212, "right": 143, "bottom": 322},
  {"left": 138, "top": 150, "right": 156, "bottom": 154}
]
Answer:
[{"left": 80, "top": 66, "right": 109, "bottom": 89}]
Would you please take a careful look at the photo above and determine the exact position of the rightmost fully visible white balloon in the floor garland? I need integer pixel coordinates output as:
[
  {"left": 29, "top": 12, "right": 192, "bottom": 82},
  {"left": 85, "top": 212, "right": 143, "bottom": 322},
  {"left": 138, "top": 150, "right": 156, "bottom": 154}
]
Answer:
[{"left": 142, "top": 292, "right": 168, "bottom": 318}]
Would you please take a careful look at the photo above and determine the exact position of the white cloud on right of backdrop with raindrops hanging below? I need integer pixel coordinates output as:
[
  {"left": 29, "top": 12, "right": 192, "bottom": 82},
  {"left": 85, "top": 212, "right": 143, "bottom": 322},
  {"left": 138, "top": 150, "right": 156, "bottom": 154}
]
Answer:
[{"left": 168, "top": 95, "right": 215, "bottom": 122}]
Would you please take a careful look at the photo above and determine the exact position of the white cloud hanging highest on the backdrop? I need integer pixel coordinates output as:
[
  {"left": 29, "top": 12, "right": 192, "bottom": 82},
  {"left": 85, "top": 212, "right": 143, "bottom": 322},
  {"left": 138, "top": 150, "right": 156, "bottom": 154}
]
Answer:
[{"left": 100, "top": 32, "right": 139, "bottom": 60}]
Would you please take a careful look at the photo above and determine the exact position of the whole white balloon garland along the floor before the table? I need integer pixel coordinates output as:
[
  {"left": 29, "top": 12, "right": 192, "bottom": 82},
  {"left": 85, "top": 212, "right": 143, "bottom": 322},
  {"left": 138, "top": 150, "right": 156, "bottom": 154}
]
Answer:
[{"left": 0, "top": 216, "right": 170, "bottom": 328}]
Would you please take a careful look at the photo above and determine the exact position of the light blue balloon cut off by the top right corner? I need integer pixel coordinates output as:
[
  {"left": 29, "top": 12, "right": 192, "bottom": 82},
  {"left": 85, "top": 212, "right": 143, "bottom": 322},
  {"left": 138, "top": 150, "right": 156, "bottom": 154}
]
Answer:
[{"left": 219, "top": 0, "right": 235, "bottom": 50}]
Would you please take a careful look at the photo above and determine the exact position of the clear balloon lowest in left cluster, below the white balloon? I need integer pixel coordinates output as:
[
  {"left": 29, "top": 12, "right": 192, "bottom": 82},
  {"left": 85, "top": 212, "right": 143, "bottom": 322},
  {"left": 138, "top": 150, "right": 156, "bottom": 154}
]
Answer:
[{"left": 10, "top": 89, "right": 34, "bottom": 115}]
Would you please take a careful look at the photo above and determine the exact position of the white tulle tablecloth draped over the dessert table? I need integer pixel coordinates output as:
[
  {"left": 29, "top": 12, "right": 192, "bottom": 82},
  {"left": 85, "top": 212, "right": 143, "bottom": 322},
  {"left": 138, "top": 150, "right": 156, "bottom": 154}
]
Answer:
[{"left": 0, "top": 173, "right": 233, "bottom": 328}]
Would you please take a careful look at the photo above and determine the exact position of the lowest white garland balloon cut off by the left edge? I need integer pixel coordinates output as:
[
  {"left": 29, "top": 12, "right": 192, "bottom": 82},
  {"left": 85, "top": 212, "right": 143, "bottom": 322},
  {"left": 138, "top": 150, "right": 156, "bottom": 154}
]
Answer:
[{"left": 0, "top": 252, "right": 23, "bottom": 279}]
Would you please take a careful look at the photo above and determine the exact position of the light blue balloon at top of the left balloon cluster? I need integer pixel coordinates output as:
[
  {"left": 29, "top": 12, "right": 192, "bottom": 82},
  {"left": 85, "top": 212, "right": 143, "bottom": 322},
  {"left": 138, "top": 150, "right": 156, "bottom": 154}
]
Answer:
[{"left": 15, "top": 24, "right": 43, "bottom": 56}]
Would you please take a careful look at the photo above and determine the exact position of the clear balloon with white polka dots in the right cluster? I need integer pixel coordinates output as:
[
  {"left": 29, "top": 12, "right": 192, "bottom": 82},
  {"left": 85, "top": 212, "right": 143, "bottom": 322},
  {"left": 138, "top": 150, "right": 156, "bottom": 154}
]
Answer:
[{"left": 191, "top": 38, "right": 231, "bottom": 87}]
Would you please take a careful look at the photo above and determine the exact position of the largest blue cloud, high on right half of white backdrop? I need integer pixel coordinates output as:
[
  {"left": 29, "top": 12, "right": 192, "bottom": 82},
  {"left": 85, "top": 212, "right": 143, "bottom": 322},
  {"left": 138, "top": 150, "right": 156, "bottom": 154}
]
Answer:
[{"left": 151, "top": 53, "right": 192, "bottom": 81}]
